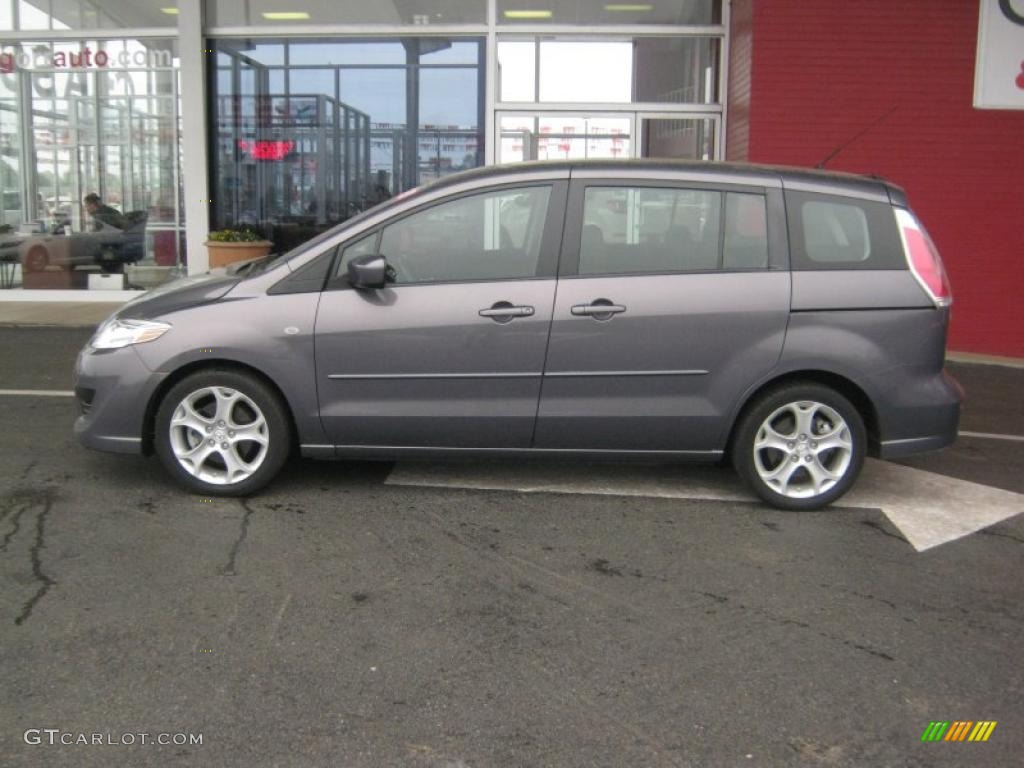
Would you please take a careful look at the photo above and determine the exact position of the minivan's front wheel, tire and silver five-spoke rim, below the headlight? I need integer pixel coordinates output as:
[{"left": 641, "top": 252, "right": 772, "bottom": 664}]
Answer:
[{"left": 155, "top": 371, "right": 291, "bottom": 496}]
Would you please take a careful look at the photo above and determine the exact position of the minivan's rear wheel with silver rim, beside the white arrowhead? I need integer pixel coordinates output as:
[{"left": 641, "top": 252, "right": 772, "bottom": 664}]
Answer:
[{"left": 731, "top": 382, "right": 867, "bottom": 510}]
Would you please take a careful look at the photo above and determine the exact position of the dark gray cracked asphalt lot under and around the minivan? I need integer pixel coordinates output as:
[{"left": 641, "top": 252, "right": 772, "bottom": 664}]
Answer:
[{"left": 0, "top": 328, "right": 1024, "bottom": 768}]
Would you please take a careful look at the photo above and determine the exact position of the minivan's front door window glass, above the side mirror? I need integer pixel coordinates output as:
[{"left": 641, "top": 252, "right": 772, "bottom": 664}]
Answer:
[{"left": 380, "top": 186, "right": 551, "bottom": 284}]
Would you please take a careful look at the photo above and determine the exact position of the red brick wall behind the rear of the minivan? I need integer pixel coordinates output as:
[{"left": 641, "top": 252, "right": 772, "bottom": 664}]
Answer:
[{"left": 726, "top": 0, "right": 1024, "bottom": 357}]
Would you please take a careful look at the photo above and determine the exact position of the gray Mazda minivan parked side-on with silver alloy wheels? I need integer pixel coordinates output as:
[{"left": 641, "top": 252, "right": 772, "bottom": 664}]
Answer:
[{"left": 75, "top": 161, "right": 961, "bottom": 509}]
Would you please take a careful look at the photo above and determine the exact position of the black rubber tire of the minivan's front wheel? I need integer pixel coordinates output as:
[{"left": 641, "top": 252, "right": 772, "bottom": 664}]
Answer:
[{"left": 154, "top": 369, "right": 292, "bottom": 497}]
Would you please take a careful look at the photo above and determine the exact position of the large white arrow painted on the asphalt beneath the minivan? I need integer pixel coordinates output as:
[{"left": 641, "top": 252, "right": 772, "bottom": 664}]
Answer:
[{"left": 386, "top": 459, "right": 1024, "bottom": 552}]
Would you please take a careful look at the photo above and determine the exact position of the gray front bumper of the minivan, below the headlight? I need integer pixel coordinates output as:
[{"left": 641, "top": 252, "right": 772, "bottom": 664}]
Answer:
[{"left": 75, "top": 346, "right": 164, "bottom": 454}]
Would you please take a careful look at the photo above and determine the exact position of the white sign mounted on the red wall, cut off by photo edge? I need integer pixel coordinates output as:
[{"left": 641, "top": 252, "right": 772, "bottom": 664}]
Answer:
[{"left": 974, "top": 0, "right": 1024, "bottom": 110}]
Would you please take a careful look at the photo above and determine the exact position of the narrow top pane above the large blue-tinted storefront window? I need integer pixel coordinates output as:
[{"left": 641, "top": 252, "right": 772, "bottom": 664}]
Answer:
[{"left": 207, "top": 0, "right": 487, "bottom": 27}]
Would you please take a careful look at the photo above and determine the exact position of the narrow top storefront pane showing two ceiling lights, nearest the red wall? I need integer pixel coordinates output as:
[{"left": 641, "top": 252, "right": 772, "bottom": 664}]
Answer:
[{"left": 498, "top": 0, "right": 722, "bottom": 26}]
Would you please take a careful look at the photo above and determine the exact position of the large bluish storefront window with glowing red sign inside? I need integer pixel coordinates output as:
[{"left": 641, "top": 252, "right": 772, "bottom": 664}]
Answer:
[{"left": 211, "top": 37, "right": 483, "bottom": 250}]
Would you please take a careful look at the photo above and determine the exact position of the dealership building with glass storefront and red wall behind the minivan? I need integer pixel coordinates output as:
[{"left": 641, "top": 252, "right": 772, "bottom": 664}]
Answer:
[{"left": 0, "top": 0, "right": 1024, "bottom": 358}]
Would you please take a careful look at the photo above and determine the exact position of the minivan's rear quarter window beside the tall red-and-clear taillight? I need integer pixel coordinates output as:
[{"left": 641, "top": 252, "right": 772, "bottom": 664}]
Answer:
[{"left": 785, "top": 191, "right": 906, "bottom": 270}]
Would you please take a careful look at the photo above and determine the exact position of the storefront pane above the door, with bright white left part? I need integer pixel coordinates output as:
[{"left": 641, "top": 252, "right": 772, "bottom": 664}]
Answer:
[{"left": 498, "top": 37, "right": 721, "bottom": 103}]
